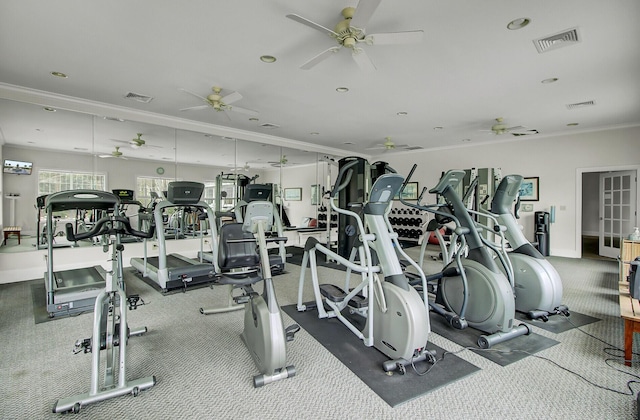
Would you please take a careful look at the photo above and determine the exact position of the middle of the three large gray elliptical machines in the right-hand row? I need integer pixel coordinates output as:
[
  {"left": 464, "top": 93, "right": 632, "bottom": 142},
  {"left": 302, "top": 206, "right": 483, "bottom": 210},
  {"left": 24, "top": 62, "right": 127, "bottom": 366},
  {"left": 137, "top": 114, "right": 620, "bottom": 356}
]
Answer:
[{"left": 400, "top": 164, "right": 530, "bottom": 349}]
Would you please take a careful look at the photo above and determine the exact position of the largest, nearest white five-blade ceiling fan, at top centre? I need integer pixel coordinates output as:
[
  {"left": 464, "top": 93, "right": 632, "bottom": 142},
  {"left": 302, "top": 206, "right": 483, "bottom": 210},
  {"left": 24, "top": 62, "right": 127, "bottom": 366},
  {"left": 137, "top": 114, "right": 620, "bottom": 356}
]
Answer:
[{"left": 287, "top": 0, "right": 424, "bottom": 71}]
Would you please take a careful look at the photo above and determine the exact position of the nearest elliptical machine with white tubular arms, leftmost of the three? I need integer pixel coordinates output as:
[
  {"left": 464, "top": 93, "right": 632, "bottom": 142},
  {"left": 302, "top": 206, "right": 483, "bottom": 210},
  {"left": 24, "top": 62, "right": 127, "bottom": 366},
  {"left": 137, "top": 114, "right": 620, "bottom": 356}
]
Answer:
[{"left": 297, "top": 161, "right": 434, "bottom": 373}]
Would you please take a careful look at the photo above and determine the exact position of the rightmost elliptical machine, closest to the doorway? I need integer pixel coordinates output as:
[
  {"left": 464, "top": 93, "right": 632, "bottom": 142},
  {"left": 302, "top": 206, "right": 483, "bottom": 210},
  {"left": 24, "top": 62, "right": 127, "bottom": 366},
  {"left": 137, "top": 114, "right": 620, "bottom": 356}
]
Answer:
[{"left": 490, "top": 175, "right": 569, "bottom": 322}]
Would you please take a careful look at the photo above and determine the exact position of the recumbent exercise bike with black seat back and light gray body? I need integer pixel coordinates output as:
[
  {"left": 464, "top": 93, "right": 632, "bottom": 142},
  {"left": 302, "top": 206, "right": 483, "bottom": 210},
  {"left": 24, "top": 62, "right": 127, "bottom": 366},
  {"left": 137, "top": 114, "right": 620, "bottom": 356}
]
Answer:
[{"left": 216, "top": 201, "right": 300, "bottom": 388}]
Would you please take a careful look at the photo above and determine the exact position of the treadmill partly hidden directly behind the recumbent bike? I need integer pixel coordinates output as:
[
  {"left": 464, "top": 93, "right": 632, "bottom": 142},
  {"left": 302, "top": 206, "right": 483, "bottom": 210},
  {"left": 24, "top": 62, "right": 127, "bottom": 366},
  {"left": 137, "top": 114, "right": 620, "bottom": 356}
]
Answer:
[{"left": 198, "top": 184, "right": 287, "bottom": 275}]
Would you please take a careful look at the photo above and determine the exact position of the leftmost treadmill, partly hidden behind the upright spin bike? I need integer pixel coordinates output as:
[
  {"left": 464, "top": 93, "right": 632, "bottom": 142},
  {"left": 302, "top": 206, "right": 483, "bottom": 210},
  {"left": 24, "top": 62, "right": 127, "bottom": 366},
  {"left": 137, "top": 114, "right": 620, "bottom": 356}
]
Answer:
[{"left": 44, "top": 190, "right": 120, "bottom": 318}]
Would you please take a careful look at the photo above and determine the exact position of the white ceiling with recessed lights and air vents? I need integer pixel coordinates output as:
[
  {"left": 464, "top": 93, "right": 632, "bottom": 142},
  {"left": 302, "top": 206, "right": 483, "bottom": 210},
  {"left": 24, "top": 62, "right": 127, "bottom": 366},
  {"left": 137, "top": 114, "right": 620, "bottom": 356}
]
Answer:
[{"left": 0, "top": 0, "right": 640, "bottom": 164}]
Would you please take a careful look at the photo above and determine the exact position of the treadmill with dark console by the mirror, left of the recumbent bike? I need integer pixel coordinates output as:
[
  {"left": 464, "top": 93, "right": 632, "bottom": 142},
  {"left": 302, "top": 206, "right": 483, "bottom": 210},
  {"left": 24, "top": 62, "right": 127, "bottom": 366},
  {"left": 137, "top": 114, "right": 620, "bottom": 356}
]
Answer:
[{"left": 131, "top": 181, "right": 220, "bottom": 293}]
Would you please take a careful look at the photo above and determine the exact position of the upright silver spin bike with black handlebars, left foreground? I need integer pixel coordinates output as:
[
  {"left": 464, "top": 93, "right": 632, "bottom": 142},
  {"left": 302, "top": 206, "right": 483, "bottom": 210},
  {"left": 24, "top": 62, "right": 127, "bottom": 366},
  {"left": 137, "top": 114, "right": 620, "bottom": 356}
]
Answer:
[{"left": 53, "top": 191, "right": 156, "bottom": 413}]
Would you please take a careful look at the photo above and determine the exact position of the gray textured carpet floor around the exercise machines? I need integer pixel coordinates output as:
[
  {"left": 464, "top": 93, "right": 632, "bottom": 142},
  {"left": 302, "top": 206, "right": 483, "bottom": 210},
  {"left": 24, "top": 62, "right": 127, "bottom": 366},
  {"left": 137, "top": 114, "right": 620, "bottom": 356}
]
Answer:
[{"left": 0, "top": 250, "right": 640, "bottom": 419}]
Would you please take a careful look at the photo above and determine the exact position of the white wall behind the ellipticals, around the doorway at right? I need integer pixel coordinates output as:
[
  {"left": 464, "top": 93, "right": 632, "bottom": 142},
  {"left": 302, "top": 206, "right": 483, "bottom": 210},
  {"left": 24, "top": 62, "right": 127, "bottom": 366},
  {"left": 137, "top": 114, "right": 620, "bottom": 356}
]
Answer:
[{"left": 379, "top": 127, "right": 640, "bottom": 258}]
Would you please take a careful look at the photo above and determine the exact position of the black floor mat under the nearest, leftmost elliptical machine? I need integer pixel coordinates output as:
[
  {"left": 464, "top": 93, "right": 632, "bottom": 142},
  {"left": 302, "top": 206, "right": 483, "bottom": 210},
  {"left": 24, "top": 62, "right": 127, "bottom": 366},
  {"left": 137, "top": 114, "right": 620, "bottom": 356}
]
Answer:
[{"left": 282, "top": 305, "right": 480, "bottom": 407}]
